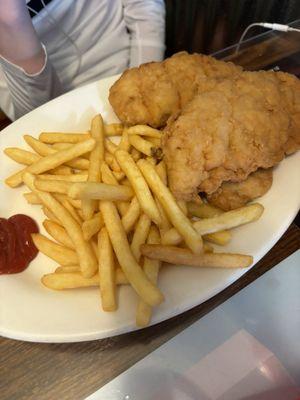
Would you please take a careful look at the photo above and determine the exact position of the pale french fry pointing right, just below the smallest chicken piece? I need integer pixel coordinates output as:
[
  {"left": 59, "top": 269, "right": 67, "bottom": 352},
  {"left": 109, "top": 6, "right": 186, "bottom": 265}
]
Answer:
[{"left": 162, "top": 203, "right": 264, "bottom": 245}]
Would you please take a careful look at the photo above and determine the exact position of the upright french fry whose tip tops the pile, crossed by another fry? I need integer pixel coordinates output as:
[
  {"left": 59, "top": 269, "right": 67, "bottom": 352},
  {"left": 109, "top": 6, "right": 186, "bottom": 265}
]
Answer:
[{"left": 81, "top": 114, "right": 104, "bottom": 220}]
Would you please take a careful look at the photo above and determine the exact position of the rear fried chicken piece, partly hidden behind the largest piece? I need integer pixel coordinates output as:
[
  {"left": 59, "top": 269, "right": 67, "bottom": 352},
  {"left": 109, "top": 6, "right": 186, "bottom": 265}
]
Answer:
[{"left": 109, "top": 52, "right": 242, "bottom": 128}]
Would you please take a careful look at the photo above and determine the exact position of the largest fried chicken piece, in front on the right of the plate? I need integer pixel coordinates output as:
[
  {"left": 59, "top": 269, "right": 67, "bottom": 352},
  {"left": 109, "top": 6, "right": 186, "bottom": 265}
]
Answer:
[{"left": 163, "top": 71, "right": 300, "bottom": 200}]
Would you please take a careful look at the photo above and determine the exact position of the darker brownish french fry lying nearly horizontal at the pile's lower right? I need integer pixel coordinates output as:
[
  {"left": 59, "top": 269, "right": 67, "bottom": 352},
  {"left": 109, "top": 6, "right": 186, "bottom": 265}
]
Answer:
[{"left": 141, "top": 244, "right": 253, "bottom": 268}]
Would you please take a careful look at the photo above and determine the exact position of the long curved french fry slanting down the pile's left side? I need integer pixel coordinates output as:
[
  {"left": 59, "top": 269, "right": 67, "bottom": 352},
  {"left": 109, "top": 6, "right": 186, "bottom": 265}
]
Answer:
[{"left": 24, "top": 173, "right": 98, "bottom": 278}]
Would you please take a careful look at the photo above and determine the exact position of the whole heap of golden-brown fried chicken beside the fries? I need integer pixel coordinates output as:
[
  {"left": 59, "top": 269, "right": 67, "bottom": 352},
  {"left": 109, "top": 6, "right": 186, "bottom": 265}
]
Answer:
[{"left": 109, "top": 53, "right": 300, "bottom": 205}]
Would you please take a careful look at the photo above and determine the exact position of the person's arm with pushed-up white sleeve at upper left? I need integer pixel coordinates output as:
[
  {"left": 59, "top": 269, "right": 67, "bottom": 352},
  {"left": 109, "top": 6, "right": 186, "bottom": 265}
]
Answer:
[{"left": 0, "top": 0, "right": 62, "bottom": 119}]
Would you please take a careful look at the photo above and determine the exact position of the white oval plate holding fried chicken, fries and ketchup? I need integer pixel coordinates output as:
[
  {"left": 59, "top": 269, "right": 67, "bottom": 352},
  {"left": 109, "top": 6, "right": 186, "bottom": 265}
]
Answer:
[{"left": 0, "top": 77, "right": 300, "bottom": 342}]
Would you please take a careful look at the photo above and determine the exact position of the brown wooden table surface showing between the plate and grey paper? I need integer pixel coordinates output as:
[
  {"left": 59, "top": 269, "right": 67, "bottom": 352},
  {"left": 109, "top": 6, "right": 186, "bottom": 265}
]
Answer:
[{"left": 0, "top": 28, "right": 300, "bottom": 400}]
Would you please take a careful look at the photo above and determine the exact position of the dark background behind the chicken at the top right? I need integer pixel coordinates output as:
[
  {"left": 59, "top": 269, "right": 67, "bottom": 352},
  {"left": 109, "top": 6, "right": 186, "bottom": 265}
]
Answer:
[{"left": 165, "top": 0, "right": 300, "bottom": 57}]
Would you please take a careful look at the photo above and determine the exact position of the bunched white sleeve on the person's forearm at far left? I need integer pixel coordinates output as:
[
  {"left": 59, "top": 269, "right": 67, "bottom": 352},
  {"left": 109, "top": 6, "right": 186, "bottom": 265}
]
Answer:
[{"left": 0, "top": 46, "right": 62, "bottom": 119}]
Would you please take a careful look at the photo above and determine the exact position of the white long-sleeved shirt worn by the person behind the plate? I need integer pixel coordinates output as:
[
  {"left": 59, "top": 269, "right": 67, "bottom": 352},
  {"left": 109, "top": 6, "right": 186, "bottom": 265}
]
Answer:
[{"left": 0, "top": 0, "right": 165, "bottom": 120}]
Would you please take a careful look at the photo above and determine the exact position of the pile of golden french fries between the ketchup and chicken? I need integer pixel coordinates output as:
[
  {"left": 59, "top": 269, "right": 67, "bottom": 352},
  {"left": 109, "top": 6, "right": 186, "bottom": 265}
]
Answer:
[{"left": 5, "top": 115, "right": 263, "bottom": 327}]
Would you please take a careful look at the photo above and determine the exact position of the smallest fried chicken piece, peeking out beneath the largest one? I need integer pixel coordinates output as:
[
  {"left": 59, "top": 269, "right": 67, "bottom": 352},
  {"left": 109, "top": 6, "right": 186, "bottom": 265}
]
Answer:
[{"left": 207, "top": 168, "right": 273, "bottom": 211}]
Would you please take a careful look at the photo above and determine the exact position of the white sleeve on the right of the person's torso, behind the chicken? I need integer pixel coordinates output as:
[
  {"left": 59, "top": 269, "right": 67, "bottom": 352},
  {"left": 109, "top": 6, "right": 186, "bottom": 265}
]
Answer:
[{"left": 123, "top": 0, "right": 165, "bottom": 67}]
